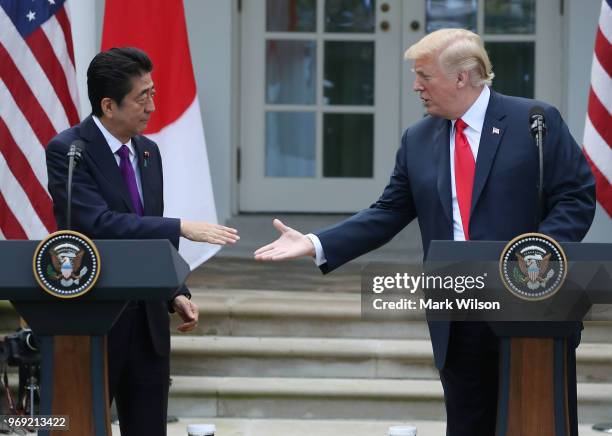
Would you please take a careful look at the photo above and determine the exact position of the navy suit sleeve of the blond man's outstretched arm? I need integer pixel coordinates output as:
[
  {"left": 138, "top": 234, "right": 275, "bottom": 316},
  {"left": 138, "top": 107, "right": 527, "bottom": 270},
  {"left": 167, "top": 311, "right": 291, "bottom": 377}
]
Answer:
[{"left": 315, "top": 131, "right": 416, "bottom": 274}]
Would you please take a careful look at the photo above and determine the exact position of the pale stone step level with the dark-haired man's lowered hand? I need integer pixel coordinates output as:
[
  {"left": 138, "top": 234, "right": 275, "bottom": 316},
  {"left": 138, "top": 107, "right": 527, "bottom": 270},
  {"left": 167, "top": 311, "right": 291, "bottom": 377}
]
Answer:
[{"left": 173, "top": 288, "right": 612, "bottom": 343}]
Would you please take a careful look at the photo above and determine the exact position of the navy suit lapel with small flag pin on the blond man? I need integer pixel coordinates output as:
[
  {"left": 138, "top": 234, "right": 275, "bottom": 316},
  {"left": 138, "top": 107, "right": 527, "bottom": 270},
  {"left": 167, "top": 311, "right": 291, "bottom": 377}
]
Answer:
[{"left": 470, "top": 90, "right": 506, "bottom": 215}]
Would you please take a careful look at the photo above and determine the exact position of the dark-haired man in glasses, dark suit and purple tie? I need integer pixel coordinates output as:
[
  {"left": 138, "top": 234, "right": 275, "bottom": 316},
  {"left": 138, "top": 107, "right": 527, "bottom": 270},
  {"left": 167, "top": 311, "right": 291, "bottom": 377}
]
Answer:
[{"left": 46, "top": 48, "right": 238, "bottom": 436}]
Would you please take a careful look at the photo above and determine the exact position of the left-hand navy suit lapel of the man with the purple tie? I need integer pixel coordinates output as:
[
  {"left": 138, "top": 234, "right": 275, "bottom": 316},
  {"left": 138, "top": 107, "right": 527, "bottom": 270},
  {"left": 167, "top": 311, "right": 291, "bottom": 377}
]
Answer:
[{"left": 81, "top": 115, "right": 135, "bottom": 212}]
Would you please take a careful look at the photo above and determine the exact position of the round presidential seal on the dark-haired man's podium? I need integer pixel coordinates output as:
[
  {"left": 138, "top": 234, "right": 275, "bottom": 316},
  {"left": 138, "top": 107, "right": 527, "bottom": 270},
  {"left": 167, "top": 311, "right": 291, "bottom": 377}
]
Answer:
[{"left": 33, "top": 230, "right": 100, "bottom": 298}]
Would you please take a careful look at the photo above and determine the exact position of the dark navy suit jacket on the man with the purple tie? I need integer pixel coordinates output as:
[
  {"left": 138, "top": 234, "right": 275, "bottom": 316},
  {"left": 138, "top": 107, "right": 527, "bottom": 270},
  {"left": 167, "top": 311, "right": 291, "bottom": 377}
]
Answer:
[{"left": 46, "top": 116, "right": 188, "bottom": 355}]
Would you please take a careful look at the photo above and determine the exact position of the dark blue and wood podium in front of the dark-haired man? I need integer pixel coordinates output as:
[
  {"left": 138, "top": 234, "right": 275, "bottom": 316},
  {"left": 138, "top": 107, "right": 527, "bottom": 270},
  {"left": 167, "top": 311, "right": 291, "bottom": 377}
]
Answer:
[{"left": 0, "top": 240, "right": 190, "bottom": 436}]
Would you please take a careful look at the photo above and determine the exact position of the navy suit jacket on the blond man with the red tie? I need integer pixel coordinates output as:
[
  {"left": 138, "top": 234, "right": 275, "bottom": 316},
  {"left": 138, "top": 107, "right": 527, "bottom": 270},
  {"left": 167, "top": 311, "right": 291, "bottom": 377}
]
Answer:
[{"left": 317, "top": 91, "right": 595, "bottom": 368}]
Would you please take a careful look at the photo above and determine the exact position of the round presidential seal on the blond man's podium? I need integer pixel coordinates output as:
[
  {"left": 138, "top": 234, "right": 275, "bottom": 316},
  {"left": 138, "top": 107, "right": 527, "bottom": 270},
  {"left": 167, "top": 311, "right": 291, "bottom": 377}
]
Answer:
[{"left": 499, "top": 233, "right": 567, "bottom": 301}]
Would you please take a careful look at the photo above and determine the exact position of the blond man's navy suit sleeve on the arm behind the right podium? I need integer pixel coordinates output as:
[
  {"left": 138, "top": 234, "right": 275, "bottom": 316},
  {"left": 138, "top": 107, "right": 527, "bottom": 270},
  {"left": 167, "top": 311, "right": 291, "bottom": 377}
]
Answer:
[{"left": 538, "top": 108, "right": 596, "bottom": 241}]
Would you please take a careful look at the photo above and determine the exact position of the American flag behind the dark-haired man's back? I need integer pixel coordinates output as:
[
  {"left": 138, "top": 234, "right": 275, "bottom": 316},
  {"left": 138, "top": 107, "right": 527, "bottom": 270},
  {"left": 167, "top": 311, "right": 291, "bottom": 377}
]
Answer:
[{"left": 0, "top": 0, "right": 79, "bottom": 239}]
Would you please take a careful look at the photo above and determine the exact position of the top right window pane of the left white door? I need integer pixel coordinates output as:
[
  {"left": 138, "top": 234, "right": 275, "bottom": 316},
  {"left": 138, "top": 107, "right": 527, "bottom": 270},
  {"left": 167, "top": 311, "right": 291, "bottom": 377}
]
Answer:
[{"left": 325, "top": 0, "right": 376, "bottom": 33}]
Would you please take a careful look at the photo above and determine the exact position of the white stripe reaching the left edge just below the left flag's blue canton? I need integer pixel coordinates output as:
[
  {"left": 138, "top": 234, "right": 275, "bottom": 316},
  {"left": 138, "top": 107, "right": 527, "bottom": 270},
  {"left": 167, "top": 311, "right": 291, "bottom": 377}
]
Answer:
[{"left": 0, "top": 8, "right": 70, "bottom": 133}]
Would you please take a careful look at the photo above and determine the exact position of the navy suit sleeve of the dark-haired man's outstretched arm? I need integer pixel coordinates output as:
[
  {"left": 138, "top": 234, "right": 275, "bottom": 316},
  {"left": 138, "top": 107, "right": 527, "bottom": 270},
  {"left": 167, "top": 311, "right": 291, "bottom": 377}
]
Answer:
[{"left": 46, "top": 139, "right": 180, "bottom": 248}]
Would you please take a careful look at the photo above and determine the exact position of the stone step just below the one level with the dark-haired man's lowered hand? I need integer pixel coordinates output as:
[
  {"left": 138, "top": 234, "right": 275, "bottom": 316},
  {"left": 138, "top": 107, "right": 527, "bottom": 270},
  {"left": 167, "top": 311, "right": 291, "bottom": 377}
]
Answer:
[{"left": 171, "top": 336, "right": 612, "bottom": 383}]
